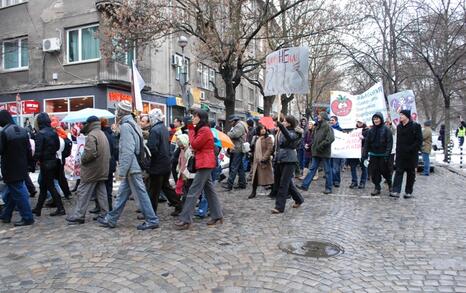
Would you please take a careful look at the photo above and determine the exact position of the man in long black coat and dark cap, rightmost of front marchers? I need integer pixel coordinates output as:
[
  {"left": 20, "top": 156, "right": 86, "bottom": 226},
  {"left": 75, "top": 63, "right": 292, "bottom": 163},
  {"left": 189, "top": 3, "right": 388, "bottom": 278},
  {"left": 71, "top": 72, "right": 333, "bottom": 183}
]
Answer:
[{"left": 390, "top": 110, "right": 422, "bottom": 198}]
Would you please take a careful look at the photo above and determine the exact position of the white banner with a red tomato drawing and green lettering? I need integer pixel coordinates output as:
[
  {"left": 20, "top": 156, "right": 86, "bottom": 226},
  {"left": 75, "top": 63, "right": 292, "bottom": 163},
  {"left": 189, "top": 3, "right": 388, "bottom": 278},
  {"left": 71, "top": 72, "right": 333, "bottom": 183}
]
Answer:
[{"left": 330, "top": 82, "right": 387, "bottom": 129}]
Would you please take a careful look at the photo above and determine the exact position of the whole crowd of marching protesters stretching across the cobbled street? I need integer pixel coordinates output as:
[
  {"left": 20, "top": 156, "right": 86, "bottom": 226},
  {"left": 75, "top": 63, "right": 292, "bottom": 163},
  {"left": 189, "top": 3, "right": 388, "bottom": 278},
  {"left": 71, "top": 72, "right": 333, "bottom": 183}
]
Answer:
[{"left": 0, "top": 101, "right": 432, "bottom": 230}]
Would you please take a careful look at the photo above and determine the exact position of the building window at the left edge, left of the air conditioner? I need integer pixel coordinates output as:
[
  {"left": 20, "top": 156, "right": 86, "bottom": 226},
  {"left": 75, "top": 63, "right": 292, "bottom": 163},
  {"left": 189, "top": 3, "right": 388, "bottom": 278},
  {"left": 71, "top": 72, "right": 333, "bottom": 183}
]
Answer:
[{"left": 2, "top": 38, "right": 29, "bottom": 70}]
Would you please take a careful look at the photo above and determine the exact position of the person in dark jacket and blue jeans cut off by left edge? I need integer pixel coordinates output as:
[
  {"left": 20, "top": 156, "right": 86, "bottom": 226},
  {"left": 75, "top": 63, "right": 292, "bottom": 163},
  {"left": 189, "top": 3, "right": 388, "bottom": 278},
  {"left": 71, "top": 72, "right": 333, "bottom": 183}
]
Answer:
[{"left": 0, "top": 110, "right": 34, "bottom": 226}]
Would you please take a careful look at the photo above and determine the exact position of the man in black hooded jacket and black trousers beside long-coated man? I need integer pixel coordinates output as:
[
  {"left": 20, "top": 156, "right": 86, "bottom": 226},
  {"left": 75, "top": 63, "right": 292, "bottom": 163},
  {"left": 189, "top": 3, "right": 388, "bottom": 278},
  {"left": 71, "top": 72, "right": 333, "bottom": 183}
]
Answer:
[{"left": 363, "top": 112, "right": 393, "bottom": 196}]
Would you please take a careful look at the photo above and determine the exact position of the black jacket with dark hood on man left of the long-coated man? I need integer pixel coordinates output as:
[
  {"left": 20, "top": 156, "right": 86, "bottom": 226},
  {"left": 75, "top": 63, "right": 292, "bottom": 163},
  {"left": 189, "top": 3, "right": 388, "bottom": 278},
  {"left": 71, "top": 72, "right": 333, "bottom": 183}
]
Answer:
[{"left": 363, "top": 113, "right": 393, "bottom": 158}]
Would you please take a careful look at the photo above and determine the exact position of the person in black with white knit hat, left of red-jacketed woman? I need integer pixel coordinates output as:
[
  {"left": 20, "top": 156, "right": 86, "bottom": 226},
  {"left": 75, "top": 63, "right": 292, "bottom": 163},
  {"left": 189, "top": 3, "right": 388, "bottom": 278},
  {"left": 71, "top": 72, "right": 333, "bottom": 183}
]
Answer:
[{"left": 147, "top": 109, "right": 182, "bottom": 216}]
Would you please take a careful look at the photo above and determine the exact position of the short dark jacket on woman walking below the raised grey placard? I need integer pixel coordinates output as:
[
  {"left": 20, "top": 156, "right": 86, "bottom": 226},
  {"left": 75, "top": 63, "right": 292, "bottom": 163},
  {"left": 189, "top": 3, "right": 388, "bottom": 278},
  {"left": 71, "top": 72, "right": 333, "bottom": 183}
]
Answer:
[{"left": 275, "top": 123, "right": 301, "bottom": 164}]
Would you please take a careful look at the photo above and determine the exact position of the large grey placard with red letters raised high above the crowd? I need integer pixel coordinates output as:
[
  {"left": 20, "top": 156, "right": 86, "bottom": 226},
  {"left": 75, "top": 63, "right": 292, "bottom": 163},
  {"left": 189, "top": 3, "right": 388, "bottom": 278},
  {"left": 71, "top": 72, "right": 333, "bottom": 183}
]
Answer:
[{"left": 264, "top": 47, "right": 309, "bottom": 96}]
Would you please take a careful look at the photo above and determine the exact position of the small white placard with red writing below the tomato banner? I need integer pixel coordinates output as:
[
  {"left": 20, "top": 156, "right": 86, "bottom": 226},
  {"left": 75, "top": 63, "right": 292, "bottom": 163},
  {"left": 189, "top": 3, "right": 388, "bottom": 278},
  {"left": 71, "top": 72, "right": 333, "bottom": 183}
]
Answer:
[{"left": 332, "top": 128, "right": 362, "bottom": 159}]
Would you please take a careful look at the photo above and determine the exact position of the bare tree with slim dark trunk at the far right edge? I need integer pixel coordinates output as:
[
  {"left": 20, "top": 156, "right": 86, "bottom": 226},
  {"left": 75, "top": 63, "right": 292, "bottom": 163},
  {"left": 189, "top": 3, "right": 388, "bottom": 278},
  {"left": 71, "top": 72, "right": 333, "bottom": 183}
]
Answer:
[{"left": 403, "top": 0, "right": 466, "bottom": 160}]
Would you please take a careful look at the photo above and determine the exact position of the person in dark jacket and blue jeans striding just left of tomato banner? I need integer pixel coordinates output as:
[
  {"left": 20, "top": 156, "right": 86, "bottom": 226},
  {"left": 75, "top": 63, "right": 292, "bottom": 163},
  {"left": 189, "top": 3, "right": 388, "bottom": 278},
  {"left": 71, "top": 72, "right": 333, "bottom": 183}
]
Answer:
[{"left": 298, "top": 111, "right": 335, "bottom": 194}]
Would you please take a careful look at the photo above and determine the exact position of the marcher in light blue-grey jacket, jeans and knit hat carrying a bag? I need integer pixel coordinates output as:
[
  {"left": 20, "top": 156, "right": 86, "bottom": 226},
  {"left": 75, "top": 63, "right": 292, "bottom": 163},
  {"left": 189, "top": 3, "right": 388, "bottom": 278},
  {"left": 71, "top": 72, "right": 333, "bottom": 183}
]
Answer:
[{"left": 97, "top": 101, "right": 159, "bottom": 230}]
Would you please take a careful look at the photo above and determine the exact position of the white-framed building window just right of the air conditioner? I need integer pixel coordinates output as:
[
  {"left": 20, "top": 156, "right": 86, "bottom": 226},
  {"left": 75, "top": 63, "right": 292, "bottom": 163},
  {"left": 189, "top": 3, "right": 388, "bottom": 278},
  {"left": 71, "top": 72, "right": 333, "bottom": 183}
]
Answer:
[{"left": 66, "top": 25, "right": 100, "bottom": 63}]
